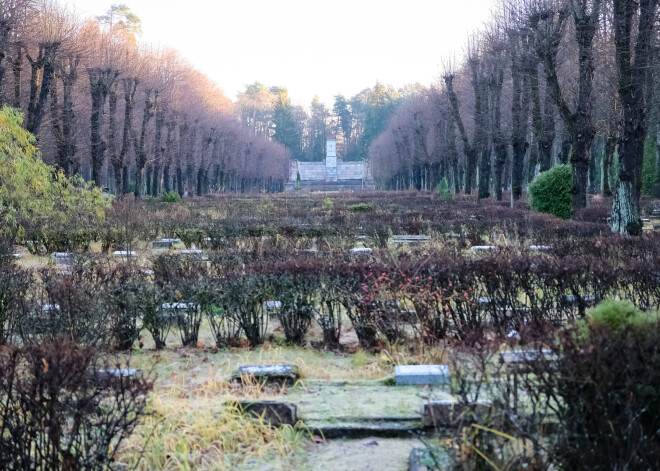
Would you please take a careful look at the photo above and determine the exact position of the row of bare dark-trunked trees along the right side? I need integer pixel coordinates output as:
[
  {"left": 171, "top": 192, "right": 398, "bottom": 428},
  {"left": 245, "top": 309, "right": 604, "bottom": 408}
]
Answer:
[{"left": 370, "top": 0, "right": 660, "bottom": 234}]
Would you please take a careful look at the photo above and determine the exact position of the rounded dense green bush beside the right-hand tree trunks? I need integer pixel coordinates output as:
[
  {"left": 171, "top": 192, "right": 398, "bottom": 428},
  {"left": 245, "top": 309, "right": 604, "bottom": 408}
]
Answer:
[{"left": 529, "top": 164, "right": 573, "bottom": 219}]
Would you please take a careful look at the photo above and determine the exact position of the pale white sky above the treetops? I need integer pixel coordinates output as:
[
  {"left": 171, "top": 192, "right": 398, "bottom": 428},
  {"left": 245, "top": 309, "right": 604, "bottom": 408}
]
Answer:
[{"left": 59, "top": 0, "right": 494, "bottom": 107}]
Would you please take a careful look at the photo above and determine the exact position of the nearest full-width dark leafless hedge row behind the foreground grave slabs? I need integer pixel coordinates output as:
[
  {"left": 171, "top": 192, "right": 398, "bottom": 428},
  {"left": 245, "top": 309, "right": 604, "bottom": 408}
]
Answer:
[{"left": 0, "top": 252, "right": 660, "bottom": 350}]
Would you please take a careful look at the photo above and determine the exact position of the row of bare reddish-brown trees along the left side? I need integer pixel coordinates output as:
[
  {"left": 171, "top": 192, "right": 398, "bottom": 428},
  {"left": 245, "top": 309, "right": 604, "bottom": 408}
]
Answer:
[{"left": 0, "top": 0, "right": 289, "bottom": 196}]
